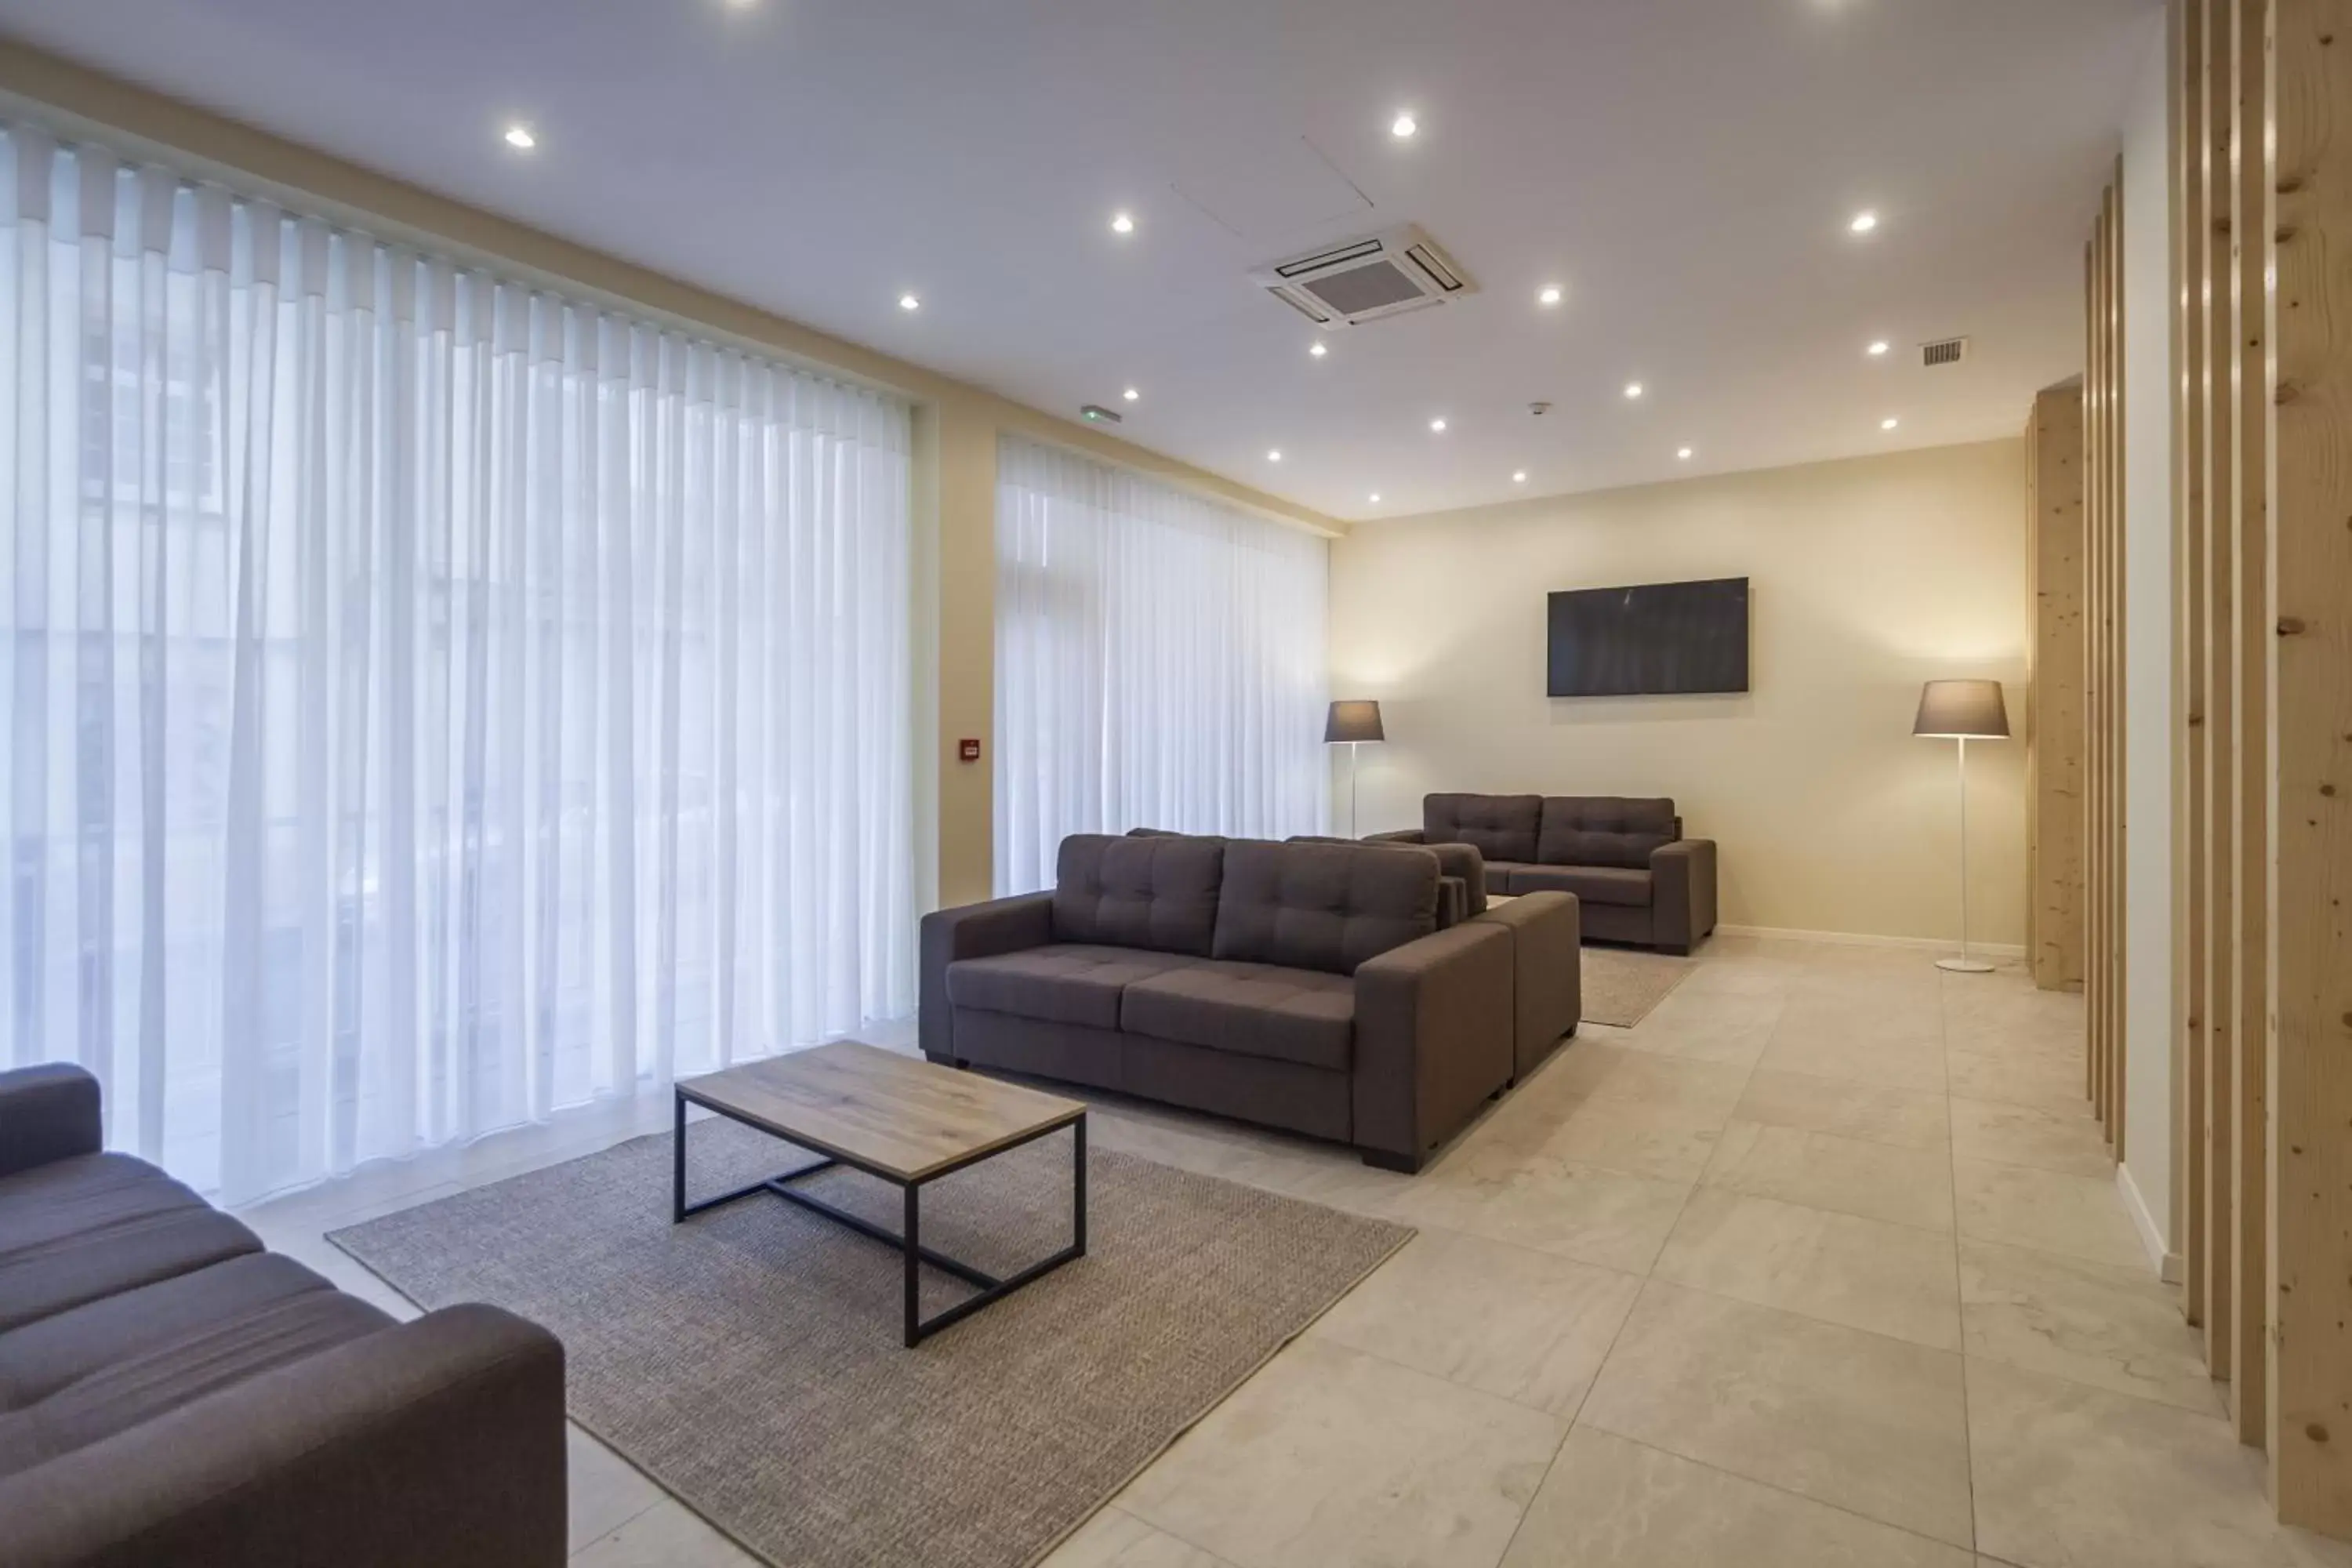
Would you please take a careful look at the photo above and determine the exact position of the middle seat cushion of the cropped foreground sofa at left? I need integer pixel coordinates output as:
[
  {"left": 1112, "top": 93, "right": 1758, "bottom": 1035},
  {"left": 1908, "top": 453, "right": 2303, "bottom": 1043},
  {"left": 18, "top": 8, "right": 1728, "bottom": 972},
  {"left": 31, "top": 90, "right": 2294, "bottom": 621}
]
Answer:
[{"left": 0, "top": 1253, "right": 334, "bottom": 1413}]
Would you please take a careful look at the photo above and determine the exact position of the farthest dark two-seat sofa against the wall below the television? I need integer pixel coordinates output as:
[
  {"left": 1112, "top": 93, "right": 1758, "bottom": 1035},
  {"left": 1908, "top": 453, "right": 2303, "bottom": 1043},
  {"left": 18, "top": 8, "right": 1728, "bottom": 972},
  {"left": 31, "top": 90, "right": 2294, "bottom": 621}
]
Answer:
[{"left": 1371, "top": 794, "right": 1715, "bottom": 952}]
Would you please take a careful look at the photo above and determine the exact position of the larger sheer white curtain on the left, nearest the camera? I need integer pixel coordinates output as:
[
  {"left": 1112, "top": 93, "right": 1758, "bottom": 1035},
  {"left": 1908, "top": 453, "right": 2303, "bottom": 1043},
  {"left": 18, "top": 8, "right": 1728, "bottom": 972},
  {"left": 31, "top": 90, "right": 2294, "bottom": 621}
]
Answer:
[{"left": 0, "top": 127, "right": 913, "bottom": 1201}]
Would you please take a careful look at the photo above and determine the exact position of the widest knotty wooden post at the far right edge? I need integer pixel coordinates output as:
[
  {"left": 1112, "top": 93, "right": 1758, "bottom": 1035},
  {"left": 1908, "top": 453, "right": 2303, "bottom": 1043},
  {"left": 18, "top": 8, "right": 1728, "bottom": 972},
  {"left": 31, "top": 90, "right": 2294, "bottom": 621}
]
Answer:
[{"left": 2267, "top": 0, "right": 2352, "bottom": 1535}]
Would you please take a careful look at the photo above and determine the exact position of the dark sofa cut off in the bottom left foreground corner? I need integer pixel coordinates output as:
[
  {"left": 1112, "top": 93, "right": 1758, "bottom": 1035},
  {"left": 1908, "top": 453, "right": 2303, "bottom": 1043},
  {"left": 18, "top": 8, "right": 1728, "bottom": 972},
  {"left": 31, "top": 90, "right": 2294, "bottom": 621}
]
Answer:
[{"left": 0, "top": 1067, "right": 567, "bottom": 1568}]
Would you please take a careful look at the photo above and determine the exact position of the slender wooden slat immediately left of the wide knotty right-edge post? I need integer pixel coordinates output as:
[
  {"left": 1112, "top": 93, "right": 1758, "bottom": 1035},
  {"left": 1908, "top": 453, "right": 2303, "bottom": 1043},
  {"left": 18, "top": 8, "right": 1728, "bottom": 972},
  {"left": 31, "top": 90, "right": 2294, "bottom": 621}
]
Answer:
[{"left": 2216, "top": 0, "right": 2274, "bottom": 1443}]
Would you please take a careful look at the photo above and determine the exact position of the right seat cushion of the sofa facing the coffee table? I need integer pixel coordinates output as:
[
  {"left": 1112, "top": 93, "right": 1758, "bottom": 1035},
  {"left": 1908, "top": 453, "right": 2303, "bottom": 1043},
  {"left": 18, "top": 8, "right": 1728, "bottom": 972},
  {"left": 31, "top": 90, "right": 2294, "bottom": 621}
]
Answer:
[{"left": 1120, "top": 959, "right": 1355, "bottom": 1072}]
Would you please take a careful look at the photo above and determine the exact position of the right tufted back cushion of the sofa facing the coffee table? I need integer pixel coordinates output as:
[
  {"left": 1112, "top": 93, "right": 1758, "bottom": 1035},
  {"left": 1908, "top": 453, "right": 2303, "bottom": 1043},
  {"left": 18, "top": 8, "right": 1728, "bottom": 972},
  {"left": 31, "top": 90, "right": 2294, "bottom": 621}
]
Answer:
[{"left": 1211, "top": 839, "right": 1437, "bottom": 975}]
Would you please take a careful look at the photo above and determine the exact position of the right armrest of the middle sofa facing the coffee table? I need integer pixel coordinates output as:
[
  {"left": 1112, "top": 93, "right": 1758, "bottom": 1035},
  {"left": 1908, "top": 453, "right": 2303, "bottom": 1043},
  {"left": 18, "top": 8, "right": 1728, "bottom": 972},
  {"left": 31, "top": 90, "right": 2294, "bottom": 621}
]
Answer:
[{"left": 1352, "top": 919, "right": 1512, "bottom": 1171}]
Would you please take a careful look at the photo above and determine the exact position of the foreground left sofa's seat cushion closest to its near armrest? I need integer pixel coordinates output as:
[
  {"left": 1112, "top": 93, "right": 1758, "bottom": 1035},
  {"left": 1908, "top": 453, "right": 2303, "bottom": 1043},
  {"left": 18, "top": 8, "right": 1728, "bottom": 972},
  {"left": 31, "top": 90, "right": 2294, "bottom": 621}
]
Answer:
[{"left": 0, "top": 1290, "right": 393, "bottom": 1476}]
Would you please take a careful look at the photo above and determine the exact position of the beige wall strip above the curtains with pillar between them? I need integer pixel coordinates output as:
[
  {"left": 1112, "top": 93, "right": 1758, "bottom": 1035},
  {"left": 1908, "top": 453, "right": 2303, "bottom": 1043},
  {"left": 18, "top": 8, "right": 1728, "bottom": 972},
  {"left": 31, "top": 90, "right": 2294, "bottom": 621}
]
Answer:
[{"left": 0, "top": 40, "right": 1345, "bottom": 907}]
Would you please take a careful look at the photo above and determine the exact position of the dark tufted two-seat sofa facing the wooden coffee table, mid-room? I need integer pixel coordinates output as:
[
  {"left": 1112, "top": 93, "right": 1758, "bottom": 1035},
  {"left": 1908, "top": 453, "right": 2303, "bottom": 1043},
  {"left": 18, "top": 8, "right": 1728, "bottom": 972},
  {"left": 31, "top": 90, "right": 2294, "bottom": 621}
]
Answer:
[{"left": 920, "top": 834, "right": 1519, "bottom": 1171}]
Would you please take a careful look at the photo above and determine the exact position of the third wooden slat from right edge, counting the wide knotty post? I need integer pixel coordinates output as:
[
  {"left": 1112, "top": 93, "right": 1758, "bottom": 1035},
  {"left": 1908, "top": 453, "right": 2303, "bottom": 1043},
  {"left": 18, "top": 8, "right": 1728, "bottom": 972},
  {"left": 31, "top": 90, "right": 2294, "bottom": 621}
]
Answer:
[{"left": 2197, "top": 0, "right": 2237, "bottom": 1377}]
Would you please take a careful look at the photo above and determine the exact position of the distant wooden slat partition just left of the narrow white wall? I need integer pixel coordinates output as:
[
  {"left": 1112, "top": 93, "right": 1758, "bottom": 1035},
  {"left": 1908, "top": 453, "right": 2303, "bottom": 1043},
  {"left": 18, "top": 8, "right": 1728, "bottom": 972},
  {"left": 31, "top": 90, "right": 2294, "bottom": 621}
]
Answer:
[{"left": 2082, "top": 169, "right": 2126, "bottom": 1159}]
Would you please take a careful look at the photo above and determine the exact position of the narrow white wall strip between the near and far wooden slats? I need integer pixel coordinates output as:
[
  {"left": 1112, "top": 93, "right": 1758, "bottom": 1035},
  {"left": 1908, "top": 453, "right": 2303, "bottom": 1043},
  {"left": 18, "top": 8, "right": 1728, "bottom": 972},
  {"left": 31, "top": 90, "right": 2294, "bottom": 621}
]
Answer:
[{"left": 2122, "top": 16, "right": 2178, "bottom": 1262}]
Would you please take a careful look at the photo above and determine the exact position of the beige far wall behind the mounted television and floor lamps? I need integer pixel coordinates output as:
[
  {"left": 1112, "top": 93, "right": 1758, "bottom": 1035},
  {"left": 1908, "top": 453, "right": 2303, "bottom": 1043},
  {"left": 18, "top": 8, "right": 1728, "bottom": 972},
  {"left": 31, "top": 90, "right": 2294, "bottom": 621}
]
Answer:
[{"left": 1331, "top": 440, "right": 2027, "bottom": 945}]
